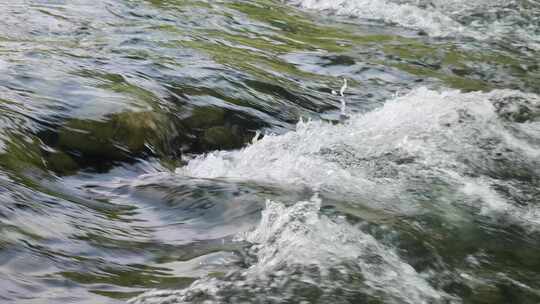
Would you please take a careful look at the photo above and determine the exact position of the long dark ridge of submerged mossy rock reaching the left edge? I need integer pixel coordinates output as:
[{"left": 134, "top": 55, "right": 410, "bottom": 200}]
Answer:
[{"left": 0, "top": 92, "right": 265, "bottom": 175}]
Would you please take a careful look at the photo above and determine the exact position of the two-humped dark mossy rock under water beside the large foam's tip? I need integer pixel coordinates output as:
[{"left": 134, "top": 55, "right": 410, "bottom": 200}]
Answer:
[{"left": 26, "top": 106, "right": 262, "bottom": 175}]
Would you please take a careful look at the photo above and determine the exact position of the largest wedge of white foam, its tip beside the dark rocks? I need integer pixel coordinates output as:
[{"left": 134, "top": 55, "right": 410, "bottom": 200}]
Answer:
[{"left": 177, "top": 88, "right": 540, "bottom": 223}]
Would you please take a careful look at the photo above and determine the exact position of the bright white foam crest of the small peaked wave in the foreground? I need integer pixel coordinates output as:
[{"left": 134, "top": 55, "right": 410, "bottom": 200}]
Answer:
[{"left": 240, "top": 197, "right": 443, "bottom": 303}]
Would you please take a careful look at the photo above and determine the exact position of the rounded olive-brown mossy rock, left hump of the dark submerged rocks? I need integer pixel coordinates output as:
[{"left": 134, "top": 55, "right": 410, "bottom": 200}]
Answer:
[{"left": 56, "top": 112, "right": 177, "bottom": 161}]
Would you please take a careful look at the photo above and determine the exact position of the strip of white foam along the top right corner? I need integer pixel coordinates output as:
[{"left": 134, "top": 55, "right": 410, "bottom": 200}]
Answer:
[{"left": 288, "top": 0, "right": 540, "bottom": 48}]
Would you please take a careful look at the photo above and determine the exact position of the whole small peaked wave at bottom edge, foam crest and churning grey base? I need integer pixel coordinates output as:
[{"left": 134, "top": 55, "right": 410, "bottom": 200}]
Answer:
[{"left": 130, "top": 196, "right": 450, "bottom": 304}]
